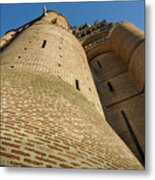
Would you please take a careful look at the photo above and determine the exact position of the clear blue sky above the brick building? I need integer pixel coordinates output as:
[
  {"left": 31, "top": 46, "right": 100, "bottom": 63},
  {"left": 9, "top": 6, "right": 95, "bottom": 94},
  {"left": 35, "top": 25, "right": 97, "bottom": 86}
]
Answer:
[{"left": 0, "top": 0, "right": 144, "bottom": 36}]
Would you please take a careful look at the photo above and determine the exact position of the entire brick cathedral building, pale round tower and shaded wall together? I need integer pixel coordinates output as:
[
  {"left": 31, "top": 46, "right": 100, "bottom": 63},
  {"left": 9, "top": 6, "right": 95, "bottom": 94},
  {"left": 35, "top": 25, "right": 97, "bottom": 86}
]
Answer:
[{"left": 0, "top": 7, "right": 145, "bottom": 170}]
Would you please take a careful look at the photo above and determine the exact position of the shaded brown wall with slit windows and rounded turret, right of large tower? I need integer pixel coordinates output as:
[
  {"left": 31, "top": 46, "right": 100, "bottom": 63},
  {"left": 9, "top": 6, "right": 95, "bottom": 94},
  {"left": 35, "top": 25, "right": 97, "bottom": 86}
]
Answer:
[{"left": 86, "top": 22, "right": 145, "bottom": 163}]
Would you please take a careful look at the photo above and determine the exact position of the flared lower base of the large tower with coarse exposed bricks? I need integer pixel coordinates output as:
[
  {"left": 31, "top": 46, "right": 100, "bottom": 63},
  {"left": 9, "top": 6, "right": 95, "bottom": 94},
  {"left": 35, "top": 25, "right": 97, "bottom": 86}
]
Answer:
[{"left": 0, "top": 67, "right": 142, "bottom": 169}]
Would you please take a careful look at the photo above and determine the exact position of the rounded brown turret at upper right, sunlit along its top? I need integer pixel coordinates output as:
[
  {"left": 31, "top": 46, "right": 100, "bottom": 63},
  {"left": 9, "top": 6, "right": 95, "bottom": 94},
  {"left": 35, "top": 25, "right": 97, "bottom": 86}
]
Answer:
[{"left": 111, "top": 22, "right": 144, "bottom": 64}]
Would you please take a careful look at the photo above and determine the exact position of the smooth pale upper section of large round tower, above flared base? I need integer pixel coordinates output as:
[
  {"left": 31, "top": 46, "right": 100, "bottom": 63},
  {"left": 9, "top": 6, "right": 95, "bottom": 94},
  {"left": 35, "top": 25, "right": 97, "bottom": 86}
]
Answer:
[{"left": 1, "top": 12, "right": 102, "bottom": 114}]
